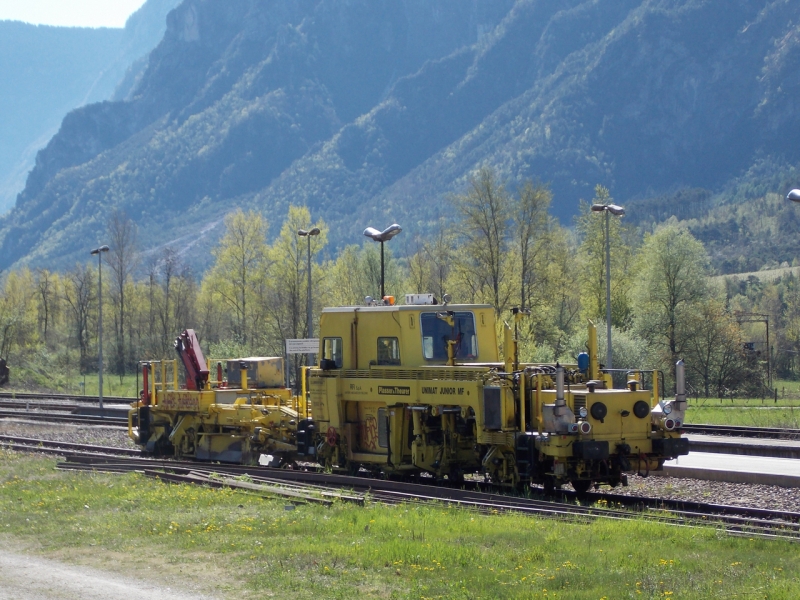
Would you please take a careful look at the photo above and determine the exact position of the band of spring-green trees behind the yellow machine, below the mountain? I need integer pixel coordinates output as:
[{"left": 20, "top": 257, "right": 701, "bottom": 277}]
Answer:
[{"left": 0, "top": 168, "right": 788, "bottom": 396}]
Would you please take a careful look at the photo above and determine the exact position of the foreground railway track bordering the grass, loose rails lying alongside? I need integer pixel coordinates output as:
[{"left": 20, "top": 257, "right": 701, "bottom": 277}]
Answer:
[{"left": 0, "top": 436, "right": 800, "bottom": 541}]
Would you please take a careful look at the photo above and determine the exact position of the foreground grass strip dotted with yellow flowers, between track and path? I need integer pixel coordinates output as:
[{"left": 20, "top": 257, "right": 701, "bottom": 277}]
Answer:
[{"left": 0, "top": 451, "right": 800, "bottom": 600}]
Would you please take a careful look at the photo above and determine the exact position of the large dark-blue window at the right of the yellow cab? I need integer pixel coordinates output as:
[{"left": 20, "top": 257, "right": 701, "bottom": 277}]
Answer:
[{"left": 419, "top": 311, "right": 478, "bottom": 361}]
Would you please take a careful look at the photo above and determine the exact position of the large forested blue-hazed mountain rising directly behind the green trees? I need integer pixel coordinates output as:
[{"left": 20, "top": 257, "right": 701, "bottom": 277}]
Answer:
[{"left": 0, "top": 0, "right": 800, "bottom": 270}]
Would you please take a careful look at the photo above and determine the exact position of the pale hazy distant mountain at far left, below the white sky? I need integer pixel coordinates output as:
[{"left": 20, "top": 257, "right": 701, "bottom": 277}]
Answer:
[{"left": 0, "top": 0, "right": 180, "bottom": 214}]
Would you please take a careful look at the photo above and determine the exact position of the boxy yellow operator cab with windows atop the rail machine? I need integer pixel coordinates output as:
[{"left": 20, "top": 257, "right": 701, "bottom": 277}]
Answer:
[{"left": 319, "top": 294, "right": 499, "bottom": 371}]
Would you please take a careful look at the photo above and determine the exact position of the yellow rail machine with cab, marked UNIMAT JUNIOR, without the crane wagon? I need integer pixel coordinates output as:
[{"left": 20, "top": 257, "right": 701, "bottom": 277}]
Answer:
[{"left": 306, "top": 294, "right": 688, "bottom": 492}]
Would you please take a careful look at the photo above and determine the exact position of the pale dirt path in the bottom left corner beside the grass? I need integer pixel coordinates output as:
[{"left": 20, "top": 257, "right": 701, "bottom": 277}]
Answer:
[{"left": 0, "top": 548, "right": 219, "bottom": 600}]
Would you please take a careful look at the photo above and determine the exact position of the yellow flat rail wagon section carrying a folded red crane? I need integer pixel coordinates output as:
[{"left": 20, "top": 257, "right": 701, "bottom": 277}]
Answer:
[{"left": 128, "top": 329, "right": 313, "bottom": 466}]
